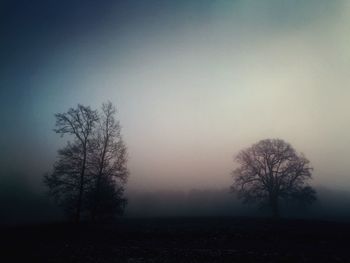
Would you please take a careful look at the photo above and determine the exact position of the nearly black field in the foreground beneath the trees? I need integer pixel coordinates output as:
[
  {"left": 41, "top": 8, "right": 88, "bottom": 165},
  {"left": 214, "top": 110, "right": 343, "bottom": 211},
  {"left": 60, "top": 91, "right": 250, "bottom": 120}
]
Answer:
[{"left": 0, "top": 218, "right": 350, "bottom": 263}]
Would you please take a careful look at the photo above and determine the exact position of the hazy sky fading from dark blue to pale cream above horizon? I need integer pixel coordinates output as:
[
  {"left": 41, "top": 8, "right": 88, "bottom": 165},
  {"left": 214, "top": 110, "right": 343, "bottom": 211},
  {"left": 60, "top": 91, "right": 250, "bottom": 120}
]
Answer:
[{"left": 0, "top": 0, "right": 350, "bottom": 196}]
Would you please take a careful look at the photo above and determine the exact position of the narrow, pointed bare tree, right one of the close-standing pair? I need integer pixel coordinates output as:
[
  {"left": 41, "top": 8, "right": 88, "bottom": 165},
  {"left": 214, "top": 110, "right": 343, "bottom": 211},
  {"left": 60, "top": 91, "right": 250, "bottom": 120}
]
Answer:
[{"left": 90, "top": 102, "right": 128, "bottom": 221}]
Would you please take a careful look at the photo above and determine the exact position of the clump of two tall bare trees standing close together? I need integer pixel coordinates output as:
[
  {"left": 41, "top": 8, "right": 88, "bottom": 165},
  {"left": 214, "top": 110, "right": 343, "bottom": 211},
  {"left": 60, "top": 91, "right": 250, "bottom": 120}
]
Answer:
[{"left": 44, "top": 102, "right": 128, "bottom": 222}]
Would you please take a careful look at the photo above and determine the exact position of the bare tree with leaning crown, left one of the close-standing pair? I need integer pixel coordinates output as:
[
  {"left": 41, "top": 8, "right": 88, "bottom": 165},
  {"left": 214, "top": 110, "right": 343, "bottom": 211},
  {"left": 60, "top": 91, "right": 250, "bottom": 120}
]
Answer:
[{"left": 44, "top": 105, "right": 98, "bottom": 222}]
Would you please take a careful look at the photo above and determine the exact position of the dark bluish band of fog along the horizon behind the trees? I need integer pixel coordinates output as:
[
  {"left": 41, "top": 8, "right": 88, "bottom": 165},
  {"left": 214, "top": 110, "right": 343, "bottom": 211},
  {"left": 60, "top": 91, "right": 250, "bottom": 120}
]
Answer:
[{"left": 0, "top": 176, "right": 350, "bottom": 225}]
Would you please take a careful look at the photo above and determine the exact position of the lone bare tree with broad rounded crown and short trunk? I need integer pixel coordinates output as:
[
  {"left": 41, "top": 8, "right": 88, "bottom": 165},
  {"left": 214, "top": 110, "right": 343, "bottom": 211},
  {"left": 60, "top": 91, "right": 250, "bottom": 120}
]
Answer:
[{"left": 231, "top": 139, "right": 316, "bottom": 218}]
